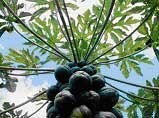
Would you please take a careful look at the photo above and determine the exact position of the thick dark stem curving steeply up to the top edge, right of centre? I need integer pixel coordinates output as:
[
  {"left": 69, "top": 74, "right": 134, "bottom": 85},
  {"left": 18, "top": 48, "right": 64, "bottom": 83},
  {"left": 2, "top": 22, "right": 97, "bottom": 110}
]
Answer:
[{"left": 85, "top": 0, "right": 115, "bottom": 62}]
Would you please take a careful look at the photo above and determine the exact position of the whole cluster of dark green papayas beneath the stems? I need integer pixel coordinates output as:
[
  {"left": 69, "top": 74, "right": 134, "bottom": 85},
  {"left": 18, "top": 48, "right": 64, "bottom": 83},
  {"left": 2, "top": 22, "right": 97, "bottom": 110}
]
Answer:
[{"left": 46, "top": 62, "right": 123, "bottom": 118}]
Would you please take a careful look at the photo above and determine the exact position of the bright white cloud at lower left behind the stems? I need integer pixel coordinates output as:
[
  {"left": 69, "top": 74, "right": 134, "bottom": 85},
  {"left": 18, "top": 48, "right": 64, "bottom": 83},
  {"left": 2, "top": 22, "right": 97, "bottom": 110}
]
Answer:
[{"left": 0, "top": 70, "right": 48, "bottom": 118}]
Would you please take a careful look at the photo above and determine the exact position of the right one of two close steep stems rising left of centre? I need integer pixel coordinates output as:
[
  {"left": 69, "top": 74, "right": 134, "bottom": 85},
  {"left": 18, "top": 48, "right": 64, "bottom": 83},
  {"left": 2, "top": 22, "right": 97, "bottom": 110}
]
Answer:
[{"left": 63, "top": 0, "right": 80, "bottom": 61}]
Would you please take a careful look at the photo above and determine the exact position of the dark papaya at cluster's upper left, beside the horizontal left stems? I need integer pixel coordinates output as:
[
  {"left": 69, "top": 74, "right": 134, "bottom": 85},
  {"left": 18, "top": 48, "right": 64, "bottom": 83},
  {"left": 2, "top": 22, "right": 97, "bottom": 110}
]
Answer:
[{"left": 54, "top": 66, "right": 72, "bottom": 84}]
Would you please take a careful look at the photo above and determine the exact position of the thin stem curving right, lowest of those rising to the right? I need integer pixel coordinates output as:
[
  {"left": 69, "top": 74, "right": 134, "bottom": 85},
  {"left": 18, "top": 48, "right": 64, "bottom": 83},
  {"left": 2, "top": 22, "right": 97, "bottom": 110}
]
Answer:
[{"left": 93, "top": 46, "right": 148, "bottom": 65}]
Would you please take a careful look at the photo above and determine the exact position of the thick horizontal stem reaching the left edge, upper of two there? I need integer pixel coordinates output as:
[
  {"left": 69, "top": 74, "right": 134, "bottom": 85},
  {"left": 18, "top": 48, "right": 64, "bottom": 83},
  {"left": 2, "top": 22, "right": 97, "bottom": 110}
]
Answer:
[{"left": 0, "top": 66, "right": 55, "bottom": 72}]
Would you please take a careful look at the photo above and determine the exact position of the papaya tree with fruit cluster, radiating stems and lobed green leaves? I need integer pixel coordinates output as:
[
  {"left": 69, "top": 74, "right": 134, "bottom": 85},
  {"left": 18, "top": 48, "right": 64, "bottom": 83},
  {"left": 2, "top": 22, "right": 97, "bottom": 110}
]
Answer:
[{"left": 0, "top": 0, "right": 159, "bottom": 118}]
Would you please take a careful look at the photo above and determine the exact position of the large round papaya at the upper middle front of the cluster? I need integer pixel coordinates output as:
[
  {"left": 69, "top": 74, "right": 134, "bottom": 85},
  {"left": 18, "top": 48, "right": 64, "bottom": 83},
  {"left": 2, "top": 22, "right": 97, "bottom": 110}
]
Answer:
[{"left": 69, "top": 71, "right": 92, "bottom": 94}]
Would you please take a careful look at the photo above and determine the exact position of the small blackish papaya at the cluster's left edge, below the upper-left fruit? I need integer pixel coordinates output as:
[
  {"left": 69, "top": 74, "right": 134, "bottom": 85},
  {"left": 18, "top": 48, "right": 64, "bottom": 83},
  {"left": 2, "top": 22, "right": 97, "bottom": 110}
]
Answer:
[{"left": 46, "top": 85, "right": 59, "bottom": 101}]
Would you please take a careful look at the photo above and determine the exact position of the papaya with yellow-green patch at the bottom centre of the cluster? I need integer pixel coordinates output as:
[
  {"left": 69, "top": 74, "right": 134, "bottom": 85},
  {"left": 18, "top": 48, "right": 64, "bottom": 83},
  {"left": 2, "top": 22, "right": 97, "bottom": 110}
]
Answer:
[{"left": 70, "top": 105, "right": 92, "bottom": 118}]
